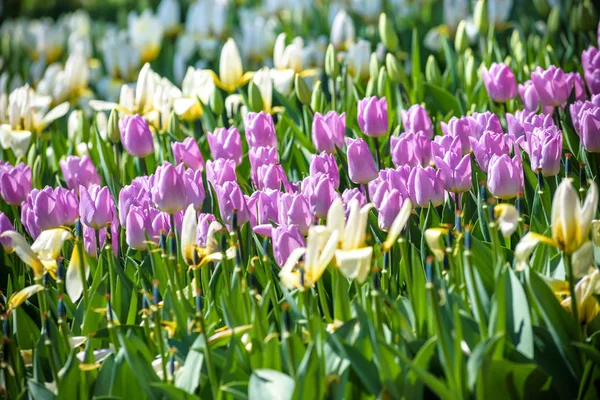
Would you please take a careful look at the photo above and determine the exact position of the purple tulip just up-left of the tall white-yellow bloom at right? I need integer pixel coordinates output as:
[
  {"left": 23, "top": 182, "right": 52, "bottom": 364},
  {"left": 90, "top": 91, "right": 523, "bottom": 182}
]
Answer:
[{"left": 518, "top": 125, "right": 562, "bottom": 176}]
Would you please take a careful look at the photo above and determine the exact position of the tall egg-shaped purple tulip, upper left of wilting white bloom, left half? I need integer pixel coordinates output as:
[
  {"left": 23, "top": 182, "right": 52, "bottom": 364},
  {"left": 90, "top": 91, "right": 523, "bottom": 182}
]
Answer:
[{"left": 150, "top": 162, "right": 187, "bottom": 214}]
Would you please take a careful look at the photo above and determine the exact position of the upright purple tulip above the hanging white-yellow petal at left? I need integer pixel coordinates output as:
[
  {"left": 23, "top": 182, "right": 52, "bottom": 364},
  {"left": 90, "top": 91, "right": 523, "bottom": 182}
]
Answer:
[{"left": 79, "top": 185, "right": 115, "bottom": 229}]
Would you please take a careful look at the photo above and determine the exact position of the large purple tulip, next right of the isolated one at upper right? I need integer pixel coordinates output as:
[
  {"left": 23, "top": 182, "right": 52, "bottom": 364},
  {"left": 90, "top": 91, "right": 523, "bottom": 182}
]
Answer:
[{"left": 531, "top": 65, "right": 571, "bottom": 107}]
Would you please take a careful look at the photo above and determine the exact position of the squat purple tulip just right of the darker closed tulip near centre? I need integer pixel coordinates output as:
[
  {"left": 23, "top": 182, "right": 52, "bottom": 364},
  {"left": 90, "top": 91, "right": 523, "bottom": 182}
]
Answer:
[{"left": 390, "top": 131, "right": 431, "bottom": 167}]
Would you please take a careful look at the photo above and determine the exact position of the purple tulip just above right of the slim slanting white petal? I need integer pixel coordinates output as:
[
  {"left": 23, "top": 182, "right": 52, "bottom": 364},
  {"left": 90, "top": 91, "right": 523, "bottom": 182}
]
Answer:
[{"left": 408, "top": 166, "right": 444, "bottom": 207}]
